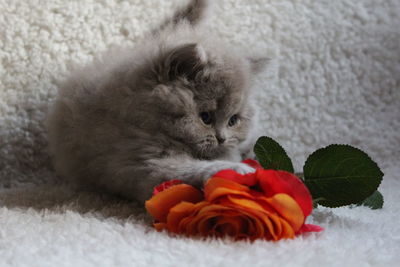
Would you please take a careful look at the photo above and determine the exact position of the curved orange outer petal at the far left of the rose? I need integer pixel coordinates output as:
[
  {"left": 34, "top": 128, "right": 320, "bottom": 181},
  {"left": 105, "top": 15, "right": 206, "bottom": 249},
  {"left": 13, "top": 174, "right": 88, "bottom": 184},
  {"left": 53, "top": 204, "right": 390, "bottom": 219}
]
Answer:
[{"left": 145, "top": 184, "right": 203, "bottom": 222}]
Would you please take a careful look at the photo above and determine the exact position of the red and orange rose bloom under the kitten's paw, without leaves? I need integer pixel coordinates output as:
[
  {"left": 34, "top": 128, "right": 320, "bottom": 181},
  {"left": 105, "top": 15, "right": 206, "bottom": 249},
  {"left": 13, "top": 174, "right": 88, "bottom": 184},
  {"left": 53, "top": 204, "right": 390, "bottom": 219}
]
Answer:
[{"left": 146, "top": 160, "right": 321, "bottom": 240}]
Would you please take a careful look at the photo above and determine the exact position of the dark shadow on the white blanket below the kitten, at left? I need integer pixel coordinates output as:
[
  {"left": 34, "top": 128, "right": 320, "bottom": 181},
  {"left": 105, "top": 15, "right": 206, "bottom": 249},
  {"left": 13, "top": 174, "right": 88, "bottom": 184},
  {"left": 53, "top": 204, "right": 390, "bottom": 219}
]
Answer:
[{"left": 0, "top": 184, "right": 151, "bottom": 224}]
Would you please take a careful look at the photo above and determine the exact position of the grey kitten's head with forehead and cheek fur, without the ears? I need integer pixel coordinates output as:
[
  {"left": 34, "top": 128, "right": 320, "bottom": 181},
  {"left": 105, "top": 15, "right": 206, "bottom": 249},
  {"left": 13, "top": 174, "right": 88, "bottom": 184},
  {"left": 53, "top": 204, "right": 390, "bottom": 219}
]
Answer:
[{"left": 148, "top": 43, "right": 252, "bottom": 159}]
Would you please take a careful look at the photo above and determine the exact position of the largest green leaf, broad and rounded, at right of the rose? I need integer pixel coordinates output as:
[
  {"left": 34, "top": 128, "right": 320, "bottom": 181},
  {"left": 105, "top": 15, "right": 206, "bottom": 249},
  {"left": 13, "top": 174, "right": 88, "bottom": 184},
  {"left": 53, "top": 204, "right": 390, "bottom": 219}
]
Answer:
[{"left": 303, "top": 145, "right": 383, "bottom": 207}]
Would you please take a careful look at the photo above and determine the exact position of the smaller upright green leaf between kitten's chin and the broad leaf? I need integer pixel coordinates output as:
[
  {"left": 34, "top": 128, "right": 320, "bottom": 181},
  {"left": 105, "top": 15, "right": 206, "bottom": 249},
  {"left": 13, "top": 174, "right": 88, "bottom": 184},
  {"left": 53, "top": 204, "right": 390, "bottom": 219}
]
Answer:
[{"left": 254, "top": 136, "right": 294, "bottom": 173}]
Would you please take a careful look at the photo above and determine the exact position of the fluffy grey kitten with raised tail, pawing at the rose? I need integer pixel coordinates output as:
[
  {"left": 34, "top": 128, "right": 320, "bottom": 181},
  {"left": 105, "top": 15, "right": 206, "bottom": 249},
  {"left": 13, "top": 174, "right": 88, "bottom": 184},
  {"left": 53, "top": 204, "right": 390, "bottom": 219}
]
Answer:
[{"left": 48, "top": 0, "right": 264, "bottom": 202}]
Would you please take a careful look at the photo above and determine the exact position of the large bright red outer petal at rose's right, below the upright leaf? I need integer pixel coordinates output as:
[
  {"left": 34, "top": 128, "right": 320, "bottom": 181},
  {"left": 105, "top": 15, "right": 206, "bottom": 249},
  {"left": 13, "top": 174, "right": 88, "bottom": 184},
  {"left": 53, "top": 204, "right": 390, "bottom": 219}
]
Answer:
[{"left": 256, "top": 170, "right": 313, "bottom": 217}]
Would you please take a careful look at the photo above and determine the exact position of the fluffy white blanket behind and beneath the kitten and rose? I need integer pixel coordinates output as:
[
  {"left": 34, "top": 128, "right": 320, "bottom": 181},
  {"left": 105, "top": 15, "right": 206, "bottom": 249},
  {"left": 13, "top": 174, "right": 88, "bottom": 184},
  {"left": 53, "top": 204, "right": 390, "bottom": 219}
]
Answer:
[{"left": 0, "top": 0, "right": 400, "bottom": 266}]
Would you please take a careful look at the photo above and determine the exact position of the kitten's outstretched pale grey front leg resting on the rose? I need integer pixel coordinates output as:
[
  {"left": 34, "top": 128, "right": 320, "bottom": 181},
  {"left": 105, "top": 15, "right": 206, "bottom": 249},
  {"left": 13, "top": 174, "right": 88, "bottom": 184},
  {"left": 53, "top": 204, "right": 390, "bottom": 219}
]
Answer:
[{"left": 122, "top": 157, "right": 255, "bottom": 202}]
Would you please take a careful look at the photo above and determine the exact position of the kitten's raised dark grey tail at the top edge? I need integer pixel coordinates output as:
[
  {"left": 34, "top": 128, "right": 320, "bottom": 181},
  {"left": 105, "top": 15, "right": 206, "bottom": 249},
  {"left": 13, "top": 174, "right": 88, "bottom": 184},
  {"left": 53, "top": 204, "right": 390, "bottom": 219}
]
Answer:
[{"left": 154, "top": 0, "right": 208, "bottom": 32}]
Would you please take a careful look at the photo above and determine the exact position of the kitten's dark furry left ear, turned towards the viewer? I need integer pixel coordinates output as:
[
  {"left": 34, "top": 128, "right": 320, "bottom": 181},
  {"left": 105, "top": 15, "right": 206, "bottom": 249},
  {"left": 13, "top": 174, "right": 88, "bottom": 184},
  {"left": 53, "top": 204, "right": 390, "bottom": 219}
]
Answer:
[{"left": 162, "top": 44, "right": 207, "bottom": 81}]
